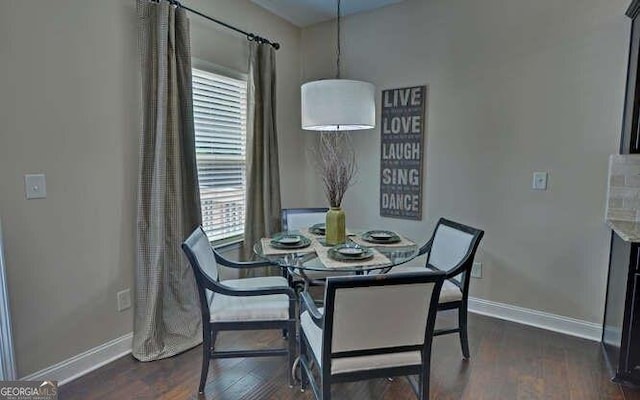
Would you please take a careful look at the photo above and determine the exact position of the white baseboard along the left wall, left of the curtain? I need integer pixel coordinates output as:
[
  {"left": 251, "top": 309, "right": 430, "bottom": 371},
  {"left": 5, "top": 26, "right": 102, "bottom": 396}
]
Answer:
[{"left": 20, "top": 333, "right": 133, "bottom": 385}]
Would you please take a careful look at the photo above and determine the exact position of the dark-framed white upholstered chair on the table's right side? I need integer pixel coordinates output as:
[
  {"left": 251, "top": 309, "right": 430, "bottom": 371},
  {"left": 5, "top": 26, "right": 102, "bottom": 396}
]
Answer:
[{"left": 390, "top": 218, "right": 484, "bottom": 358}]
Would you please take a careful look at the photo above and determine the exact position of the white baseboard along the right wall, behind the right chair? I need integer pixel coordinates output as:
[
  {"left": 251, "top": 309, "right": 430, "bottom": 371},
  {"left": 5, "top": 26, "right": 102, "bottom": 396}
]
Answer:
[{"left": 469, "top": 297, "right": 602, "bottom": 342}]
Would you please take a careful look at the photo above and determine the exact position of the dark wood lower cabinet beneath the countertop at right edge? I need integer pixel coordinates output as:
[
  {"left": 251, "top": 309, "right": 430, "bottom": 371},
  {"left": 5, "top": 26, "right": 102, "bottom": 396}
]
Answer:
[{"left": 602, "top": 233, "right": 640, "bottom": 385}]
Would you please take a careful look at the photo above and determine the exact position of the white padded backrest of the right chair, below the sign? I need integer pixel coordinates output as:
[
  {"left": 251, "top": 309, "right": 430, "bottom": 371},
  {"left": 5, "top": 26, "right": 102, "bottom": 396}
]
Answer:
[{"left": 427, "top": 218, "right": 484, "bottom": 279}]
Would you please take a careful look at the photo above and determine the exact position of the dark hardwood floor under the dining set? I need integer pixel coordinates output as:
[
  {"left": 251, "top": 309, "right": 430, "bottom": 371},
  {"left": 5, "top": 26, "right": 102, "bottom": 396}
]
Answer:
[{"left": 59, "top": 313, "right": 640, "bottom": 400}]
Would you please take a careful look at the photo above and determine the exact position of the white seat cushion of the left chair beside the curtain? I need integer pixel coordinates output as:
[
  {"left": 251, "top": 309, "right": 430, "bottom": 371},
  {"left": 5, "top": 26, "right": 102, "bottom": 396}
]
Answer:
[{"left": 209, "top": 276, "right": 289, "bottom": 322}]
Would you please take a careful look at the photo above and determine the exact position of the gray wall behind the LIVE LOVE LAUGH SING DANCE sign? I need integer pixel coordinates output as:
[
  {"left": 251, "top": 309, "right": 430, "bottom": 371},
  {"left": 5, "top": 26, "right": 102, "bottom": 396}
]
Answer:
[{"left": 301, "top": 0, "right": 630, "bottom": 323}]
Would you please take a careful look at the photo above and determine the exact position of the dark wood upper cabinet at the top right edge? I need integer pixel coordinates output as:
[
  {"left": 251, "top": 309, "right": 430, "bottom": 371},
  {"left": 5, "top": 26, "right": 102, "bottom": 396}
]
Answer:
[{"left": 620, "top": 0, "right": 640, "bottom": 154}]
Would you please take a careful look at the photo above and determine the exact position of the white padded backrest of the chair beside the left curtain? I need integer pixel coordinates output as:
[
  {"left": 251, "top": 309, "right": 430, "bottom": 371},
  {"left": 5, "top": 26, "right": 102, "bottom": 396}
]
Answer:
[{"left": 182, "top": 226, "right": 218, "bottom": 315}]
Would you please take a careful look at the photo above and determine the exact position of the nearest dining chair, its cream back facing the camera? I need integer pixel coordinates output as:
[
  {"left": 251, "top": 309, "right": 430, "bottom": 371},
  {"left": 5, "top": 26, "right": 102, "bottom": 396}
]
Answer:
[{"left": 299, "top": 271, "right": 445, "bottom": 400}]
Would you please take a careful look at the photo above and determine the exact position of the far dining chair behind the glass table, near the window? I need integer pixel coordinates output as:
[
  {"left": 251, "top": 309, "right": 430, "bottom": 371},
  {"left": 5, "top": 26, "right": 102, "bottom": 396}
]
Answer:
[{"left": 280, "top": 208, "right": 339, "bottom": 290}]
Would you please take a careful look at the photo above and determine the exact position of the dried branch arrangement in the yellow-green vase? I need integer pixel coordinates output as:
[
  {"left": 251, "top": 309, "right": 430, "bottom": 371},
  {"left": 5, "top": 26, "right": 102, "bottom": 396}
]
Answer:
[{"left": 310, "top": 132, "right": 358, "bottom": 207}]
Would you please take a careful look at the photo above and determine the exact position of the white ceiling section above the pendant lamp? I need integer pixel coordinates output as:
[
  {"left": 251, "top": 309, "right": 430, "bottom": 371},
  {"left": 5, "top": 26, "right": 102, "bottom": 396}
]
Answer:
[{"left": 251, "top": 0, "right": 403, "bottom": 28}]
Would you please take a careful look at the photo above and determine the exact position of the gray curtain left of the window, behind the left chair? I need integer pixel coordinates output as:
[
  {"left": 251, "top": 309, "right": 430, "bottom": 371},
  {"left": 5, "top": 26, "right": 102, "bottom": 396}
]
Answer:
[{"left": 133, "top": 0, "right": 202, "bottom": 361}]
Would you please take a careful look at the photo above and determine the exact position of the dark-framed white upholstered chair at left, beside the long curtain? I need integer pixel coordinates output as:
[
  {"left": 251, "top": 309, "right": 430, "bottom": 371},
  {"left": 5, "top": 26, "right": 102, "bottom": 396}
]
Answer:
[{"left": 182, "top": 227, "right": 296, "bottom": 393}]
